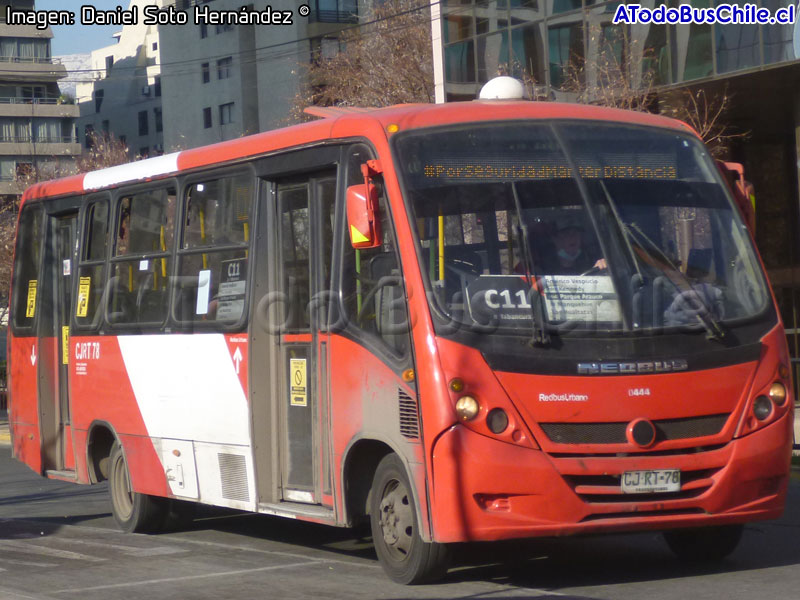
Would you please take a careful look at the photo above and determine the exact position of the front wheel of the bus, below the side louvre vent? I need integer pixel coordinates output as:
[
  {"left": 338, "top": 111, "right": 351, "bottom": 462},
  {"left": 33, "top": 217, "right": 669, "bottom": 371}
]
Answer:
[{"left": 369, "top": 454, "right": 449, "bottom": 584}]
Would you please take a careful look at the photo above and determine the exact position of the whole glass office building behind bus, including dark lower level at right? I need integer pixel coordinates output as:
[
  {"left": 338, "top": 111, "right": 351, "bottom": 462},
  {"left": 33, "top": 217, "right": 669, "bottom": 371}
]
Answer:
[{"left": 438, "top": 0, "right": 800, "bottom": 396}]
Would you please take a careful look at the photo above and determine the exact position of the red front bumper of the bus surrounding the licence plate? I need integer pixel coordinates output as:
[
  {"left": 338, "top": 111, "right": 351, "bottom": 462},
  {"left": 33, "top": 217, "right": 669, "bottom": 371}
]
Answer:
[{"left": 431, "top": 411, "right": 793, "bottom": 542}]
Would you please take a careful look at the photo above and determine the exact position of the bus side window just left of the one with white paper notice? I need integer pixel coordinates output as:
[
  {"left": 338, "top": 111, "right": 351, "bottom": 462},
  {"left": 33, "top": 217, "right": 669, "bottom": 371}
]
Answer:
[{"left": 107, "top": 188, "right": 175, "bottom": 325}]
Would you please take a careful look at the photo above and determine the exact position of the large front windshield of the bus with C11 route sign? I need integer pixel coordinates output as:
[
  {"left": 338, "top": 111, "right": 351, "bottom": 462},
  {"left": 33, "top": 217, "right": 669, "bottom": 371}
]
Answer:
[{"left": 396, "top": 122, "right": 768, "bottom": 337}]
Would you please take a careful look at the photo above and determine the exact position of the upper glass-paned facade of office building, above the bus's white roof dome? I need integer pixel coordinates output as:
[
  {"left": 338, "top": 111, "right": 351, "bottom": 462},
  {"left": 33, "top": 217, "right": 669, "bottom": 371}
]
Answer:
[{"left": 440, "top": 0, "right": 797, "bottom": 100}]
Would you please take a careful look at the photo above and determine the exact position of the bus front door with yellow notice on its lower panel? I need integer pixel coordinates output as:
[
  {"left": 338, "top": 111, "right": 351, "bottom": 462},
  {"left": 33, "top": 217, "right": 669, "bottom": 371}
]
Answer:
[{"left": 262, "top": 170, "right": 336, "bottom": 509}]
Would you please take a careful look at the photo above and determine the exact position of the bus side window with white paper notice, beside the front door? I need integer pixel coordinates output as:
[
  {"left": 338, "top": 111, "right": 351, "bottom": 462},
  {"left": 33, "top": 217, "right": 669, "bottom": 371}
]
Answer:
[{"left": 175, "top": 173, "right": 253, "bottom": 325}]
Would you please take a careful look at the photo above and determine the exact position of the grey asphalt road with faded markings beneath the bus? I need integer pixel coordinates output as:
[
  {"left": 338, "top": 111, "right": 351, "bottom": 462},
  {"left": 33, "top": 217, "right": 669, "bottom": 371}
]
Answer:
[{"left": 0, "top": 447, "right": 800, "bottom": 600}]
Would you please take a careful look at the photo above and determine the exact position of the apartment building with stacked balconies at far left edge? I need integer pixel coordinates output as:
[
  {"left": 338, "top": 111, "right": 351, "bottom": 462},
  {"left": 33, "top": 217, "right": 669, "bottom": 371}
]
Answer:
[{"left": 0, "top": 0, "right": 80, "bottom": 196}]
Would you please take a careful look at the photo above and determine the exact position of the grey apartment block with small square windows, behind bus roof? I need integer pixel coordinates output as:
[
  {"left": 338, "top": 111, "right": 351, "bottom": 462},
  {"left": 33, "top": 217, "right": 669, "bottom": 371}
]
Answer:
[{"left": 160, "top": 0, "right": 359, "bottom": 151}]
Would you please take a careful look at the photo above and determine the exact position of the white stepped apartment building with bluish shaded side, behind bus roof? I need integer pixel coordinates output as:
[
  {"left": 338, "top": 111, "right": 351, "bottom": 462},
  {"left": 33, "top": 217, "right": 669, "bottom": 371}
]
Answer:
[{"left": 76, "top": 0, "right": 164, "bottom": 158}]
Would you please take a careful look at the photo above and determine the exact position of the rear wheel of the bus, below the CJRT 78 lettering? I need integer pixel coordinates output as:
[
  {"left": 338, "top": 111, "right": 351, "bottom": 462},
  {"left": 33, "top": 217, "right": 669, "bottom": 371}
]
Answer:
[{"left": 108, "top": 442, "right": 168, "bottom": 533}]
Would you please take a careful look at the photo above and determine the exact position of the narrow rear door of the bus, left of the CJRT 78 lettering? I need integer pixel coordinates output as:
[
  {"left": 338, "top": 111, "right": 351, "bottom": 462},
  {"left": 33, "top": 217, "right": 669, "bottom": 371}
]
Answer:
[{"left": 39, "top": 213, "right": 78, "bottom": 474}]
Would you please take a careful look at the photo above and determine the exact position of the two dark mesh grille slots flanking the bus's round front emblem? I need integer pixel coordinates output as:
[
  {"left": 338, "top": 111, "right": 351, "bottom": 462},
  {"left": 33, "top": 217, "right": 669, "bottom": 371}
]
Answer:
[{"left": 539, "top": 413, "right": 730, "bottom": 444}]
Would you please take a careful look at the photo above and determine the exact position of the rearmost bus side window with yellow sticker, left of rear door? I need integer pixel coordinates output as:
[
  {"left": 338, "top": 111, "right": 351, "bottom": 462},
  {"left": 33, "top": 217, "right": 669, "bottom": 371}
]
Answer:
[{"left": 12, "top": 204, "right": 43, "bottom": 335}]
